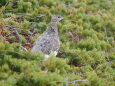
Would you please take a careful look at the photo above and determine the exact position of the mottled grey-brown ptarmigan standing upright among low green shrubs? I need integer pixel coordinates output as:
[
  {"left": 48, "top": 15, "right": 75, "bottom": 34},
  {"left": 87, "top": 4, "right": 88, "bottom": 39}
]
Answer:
[{"left": 31, "top": 15, "right": 63, "bottom": 59}]
